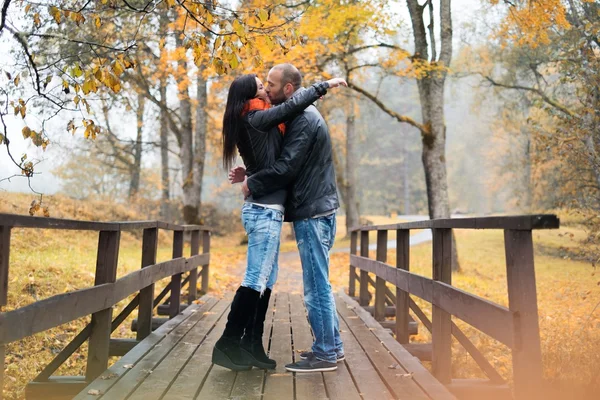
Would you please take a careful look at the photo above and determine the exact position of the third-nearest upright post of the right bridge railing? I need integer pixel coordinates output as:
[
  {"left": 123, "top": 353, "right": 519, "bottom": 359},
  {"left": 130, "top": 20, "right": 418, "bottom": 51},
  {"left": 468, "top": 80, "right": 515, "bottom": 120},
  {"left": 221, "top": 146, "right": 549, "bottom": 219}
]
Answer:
[{"left": 396, "top": 229, "right": 410, "bottom": 344}]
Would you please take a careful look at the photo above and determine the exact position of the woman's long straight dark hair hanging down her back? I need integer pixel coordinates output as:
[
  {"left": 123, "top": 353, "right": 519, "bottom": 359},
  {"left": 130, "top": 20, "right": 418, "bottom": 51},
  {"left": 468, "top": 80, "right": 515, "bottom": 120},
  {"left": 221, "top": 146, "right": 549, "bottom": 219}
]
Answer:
[{"left": 223, "top": 74, "right": 258, "bottom": 170}]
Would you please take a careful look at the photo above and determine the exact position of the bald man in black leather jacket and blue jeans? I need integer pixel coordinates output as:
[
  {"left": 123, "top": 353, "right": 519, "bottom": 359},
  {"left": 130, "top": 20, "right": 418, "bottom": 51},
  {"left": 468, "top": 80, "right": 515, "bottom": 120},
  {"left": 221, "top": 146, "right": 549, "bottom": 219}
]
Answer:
[{"left": 242, "top": 64, "right": 345, "bottom": 372}]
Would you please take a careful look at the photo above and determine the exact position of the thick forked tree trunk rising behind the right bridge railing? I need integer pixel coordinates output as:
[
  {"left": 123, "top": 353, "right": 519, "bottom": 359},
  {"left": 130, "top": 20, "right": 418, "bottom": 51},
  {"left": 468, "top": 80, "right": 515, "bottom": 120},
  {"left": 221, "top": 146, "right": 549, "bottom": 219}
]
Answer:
[{"left": 407, "top": 0, "right": 460, "bottom": 271}]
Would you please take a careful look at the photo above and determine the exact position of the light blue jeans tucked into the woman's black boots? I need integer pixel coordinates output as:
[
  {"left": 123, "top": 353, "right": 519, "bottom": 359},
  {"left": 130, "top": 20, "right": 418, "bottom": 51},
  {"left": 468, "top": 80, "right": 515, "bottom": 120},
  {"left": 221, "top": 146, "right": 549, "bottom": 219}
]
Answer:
[{"left": 242, "top": 203, "right": 283, "bottom": 295}]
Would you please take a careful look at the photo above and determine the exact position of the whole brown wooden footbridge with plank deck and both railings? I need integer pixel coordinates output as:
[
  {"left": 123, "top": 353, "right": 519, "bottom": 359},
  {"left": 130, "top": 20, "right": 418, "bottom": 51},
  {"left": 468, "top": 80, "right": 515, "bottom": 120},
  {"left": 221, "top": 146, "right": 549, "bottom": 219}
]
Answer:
[{"left": 0, "top": 214, "right": 559, "bottom": 400}]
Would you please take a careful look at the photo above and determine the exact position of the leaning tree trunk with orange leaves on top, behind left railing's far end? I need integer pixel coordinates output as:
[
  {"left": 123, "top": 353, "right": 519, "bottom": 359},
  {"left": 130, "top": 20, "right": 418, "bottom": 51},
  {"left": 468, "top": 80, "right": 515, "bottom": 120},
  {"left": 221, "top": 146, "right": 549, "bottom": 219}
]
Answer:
[{"left": 175, "top": 33, "right": 200, "bottom": 224}]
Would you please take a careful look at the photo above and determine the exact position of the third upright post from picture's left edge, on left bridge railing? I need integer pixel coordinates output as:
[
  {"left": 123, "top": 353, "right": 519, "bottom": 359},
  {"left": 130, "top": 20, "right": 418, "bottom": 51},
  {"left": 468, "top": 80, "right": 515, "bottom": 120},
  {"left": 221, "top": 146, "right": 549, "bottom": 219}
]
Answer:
[{"left": 136, "top": 228, "right": 158, "bottom": 340}]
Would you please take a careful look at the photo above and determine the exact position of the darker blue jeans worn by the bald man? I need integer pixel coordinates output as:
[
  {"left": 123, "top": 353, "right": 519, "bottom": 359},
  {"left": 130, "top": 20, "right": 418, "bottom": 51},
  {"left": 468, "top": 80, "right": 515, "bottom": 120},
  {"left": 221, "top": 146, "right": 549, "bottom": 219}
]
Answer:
[{"left": 294, "top": 214, "right": 344, "bottom": 362}]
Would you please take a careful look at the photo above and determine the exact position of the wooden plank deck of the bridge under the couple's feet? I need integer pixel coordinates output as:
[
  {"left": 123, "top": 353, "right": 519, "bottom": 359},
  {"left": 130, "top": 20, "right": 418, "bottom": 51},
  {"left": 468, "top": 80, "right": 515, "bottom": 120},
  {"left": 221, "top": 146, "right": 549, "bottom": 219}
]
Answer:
[{"left": 75, "top": 291, "right": 454, "bottom": 400}]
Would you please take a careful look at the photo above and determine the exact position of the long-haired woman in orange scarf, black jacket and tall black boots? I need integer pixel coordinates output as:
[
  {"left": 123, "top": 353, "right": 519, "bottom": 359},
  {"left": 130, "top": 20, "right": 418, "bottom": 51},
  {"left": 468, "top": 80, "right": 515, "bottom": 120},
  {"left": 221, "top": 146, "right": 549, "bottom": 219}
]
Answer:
[{"left": 212, "top": 74, "right": 346, "bottom": 371}]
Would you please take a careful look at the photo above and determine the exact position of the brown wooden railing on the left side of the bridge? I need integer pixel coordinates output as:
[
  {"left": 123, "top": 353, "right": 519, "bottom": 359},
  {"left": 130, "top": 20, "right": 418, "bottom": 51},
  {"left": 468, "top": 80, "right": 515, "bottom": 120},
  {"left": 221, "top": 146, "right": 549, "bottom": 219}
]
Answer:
[{"left": 0, "top": 214, "right": 210, "bottom": 399}]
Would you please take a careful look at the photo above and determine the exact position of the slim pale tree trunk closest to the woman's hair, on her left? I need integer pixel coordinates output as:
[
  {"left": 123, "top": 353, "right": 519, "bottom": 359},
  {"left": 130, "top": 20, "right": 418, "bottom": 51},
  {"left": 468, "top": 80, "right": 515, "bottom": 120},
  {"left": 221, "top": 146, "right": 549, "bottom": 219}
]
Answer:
[{"left": 194, "top": 66, "right": 208, "bottom": 222}]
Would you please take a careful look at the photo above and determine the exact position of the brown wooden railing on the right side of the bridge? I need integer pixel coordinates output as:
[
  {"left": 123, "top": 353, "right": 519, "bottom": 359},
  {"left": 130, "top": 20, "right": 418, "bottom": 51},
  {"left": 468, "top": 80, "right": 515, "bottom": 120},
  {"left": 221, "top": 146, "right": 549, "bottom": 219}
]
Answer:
[{"left": 349, "top": 215, "right": 560, "bottom": 399}]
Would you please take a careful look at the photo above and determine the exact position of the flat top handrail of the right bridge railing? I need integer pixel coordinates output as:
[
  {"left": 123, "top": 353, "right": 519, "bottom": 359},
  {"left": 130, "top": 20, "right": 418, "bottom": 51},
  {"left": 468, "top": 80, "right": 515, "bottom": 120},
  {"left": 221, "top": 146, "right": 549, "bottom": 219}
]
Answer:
[{"left": 350, "top": 214, "right": 560, "bottom": 232}]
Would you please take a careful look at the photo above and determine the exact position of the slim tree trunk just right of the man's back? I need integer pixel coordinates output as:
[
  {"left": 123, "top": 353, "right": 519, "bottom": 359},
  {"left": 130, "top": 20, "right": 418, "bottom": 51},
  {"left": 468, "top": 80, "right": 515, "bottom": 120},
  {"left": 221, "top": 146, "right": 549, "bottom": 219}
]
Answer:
[{"left": 344, "top": 110, "right": 360, "bottom": 236}]
